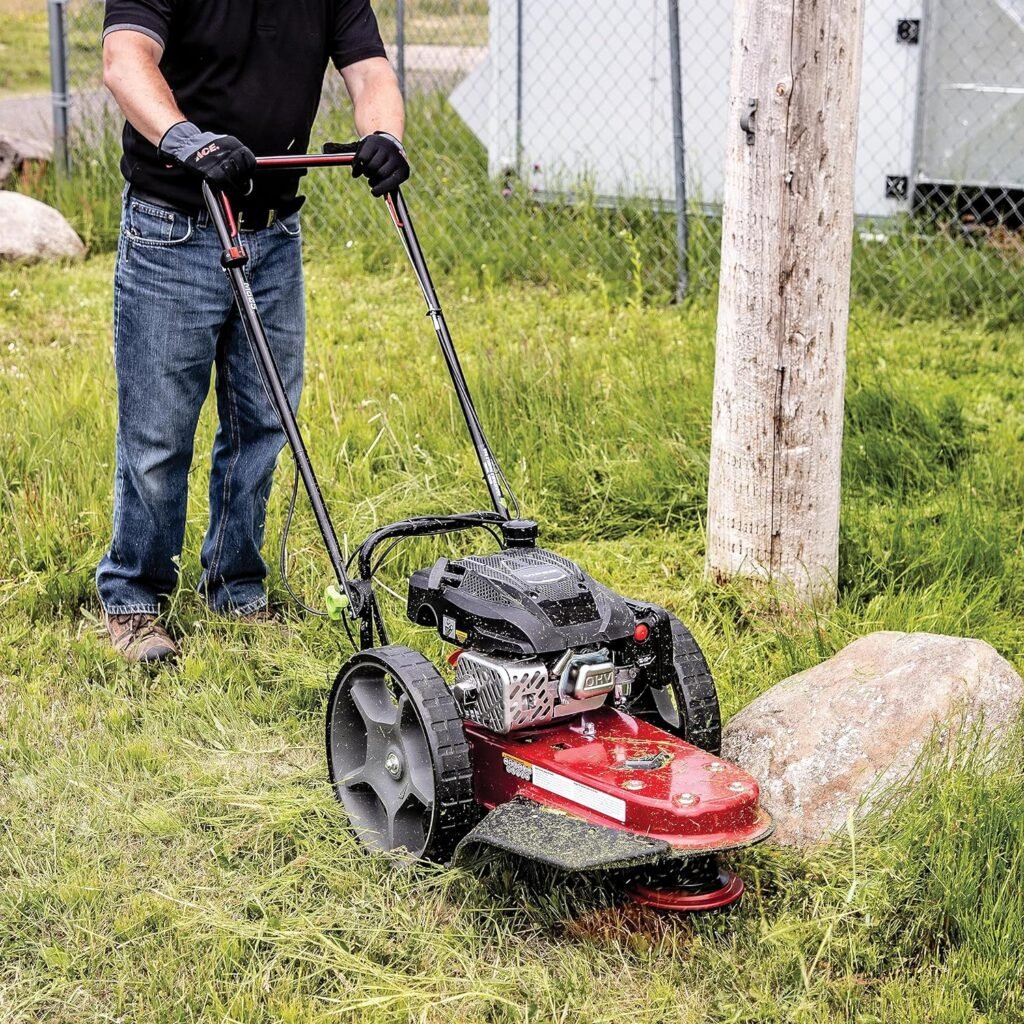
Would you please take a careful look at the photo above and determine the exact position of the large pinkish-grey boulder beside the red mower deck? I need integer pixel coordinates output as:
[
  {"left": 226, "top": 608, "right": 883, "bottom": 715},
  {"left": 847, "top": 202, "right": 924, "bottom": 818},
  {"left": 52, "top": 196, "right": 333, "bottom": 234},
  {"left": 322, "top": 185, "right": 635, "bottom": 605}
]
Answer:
[{"left": 722, "top": 633, "right": 1024, "bottom": 846}]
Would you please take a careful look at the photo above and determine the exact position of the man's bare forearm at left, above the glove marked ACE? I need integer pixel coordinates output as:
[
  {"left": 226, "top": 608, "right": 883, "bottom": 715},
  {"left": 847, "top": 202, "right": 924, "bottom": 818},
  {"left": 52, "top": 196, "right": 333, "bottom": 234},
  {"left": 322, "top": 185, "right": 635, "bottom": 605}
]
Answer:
[{"left": 103, "top": 30, "right": 185, "bottom": 145}]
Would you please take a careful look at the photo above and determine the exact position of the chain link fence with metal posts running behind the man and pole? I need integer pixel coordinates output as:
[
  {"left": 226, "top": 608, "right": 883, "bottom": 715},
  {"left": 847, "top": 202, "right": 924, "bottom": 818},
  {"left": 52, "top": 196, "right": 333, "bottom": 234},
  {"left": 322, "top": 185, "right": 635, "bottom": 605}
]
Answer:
[{"left": 51, "top": 0, "right": 1024, "bottom": 314}]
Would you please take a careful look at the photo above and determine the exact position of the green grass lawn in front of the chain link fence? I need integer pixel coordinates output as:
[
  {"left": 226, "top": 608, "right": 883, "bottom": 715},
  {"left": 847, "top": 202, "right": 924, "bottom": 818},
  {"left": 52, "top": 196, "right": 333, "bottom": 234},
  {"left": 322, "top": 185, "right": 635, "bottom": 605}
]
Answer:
[{"left": 0, "top": 242, "right": 1024, "bottom": 1024}]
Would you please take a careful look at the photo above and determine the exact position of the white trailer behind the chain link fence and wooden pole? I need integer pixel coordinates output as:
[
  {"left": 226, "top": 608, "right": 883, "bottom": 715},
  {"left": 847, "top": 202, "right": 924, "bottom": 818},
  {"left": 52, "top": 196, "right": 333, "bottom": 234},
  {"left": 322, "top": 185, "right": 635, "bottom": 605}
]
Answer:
[{"left": 452, "top": 0, "right": 1024, "bottom": 218}]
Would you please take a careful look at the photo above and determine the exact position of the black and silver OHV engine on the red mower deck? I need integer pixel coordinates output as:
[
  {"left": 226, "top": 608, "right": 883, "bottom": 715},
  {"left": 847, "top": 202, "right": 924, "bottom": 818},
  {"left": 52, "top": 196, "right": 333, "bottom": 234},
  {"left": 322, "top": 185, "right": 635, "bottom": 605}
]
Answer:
[{"left": 409, "top": 548, "right": 667, "bottom": 733}]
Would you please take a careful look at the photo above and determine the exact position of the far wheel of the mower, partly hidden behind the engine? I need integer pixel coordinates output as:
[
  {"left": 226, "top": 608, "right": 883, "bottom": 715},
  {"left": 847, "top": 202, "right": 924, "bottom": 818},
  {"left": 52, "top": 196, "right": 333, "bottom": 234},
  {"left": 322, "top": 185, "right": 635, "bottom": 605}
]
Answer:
[{"left": 627, "top": 609, "right": 722, "bottom": 756}]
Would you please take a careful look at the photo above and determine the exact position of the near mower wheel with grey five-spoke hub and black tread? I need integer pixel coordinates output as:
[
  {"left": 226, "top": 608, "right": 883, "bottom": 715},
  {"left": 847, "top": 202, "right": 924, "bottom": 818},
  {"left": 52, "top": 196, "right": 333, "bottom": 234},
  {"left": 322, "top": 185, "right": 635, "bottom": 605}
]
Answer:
[{"left": 327, "top": 644, "right": 477, "bottom": 861}]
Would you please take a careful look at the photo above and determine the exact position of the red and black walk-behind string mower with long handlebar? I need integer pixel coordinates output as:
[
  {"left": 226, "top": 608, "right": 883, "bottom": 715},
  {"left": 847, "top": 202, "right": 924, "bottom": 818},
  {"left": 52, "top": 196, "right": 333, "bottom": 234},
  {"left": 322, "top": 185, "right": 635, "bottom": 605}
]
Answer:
[{"left": 204, "top": 153, "right": 772, "bottom": 910}]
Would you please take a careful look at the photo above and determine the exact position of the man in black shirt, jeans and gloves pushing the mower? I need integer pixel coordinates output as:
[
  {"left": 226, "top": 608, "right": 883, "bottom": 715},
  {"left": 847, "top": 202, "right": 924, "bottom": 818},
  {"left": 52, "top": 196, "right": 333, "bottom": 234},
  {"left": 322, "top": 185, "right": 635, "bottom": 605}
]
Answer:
[{"left": 96, "top": 0, "right": 409, "bottom": 662}]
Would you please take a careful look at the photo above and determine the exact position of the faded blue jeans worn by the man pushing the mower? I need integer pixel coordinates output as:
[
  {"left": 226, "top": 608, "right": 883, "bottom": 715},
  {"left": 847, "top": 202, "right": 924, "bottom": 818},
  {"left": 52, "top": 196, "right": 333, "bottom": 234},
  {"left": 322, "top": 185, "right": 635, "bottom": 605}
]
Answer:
[{"left": 96, "top": 190, "right": 305, "bottom": 614}]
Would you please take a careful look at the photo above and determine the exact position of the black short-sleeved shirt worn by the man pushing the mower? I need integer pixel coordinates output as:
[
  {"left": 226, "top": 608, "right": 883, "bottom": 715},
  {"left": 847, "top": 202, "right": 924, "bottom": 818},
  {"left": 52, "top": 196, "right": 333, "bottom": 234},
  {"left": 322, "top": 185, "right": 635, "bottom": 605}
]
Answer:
[{"left": 103, "top": 0, "right": 385, "bottom": 209}]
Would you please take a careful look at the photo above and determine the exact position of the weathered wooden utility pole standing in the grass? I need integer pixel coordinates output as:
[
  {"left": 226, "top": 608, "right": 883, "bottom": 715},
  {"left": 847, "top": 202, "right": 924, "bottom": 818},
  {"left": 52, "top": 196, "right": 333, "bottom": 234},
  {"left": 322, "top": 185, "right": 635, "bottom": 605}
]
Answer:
[{"left": 708, "top": 0, "right": 864, "bottom": 603}]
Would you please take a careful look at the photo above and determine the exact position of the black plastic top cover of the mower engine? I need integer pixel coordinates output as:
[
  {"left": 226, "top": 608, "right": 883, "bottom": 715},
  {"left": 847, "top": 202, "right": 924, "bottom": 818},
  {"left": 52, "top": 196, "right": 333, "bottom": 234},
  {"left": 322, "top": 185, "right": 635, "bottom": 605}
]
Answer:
[{"left": 409, "top": 548, "right": 636, "bottom": 657}]
